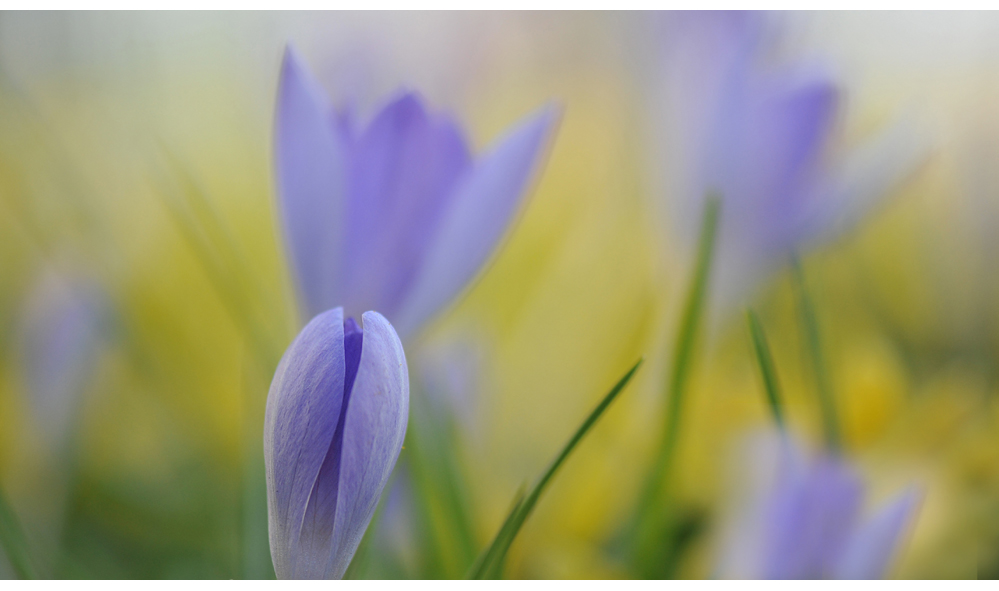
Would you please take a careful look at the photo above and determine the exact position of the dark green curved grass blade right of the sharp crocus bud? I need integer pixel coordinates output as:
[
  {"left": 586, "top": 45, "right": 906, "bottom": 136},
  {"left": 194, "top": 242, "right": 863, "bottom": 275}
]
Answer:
[{"left": 467, "top": 359, "right": 643, "bottom": 579}]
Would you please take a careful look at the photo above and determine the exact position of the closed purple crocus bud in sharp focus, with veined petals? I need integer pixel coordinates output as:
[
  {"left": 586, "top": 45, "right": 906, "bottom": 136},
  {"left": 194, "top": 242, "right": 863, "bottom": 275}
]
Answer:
[{"left": 264, "top": 308, "right": 409, "bottom": 579}]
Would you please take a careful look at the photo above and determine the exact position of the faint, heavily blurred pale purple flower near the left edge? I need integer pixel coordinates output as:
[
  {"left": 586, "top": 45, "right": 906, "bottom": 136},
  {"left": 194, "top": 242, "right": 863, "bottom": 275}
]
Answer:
[{"left": 23, "top": 271, "right": 108, "bottom": 454}]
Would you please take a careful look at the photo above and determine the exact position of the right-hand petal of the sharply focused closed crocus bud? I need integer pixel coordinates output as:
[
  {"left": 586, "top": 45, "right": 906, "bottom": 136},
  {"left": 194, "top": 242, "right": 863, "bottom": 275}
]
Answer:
[{"left": 326, "top": 312, "right": 409, "bottom": 578}]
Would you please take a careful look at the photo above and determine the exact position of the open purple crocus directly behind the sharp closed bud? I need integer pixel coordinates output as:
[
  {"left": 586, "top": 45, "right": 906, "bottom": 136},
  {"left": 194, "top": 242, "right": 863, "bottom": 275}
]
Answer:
[{"left": 275, "top": 48, "right": 558, "bottom": 339}]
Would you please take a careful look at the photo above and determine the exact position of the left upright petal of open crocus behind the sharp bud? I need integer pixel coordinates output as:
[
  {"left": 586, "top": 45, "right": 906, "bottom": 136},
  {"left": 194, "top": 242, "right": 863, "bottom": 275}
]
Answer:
[{"left": 275, "top": 47, "right": 346, "bottom": 318}]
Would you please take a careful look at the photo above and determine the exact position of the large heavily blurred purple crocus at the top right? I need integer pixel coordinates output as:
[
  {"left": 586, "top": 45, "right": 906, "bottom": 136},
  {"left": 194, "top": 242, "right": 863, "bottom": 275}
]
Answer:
[{"left": 652, "top": 12, "right": 928, "bottom": 307}]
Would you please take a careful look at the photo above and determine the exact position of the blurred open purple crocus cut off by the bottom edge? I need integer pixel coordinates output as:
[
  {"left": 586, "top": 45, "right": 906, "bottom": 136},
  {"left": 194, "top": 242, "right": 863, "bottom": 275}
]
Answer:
[{"left": 716, "top": 436, "right": 919, "bottom": 579}]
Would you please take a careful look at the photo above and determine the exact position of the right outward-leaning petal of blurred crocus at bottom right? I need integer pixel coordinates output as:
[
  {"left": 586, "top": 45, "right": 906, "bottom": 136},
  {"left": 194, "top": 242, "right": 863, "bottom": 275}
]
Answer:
[{"left": 835, "top": 490, "right": 920, "bottom": 579}]
